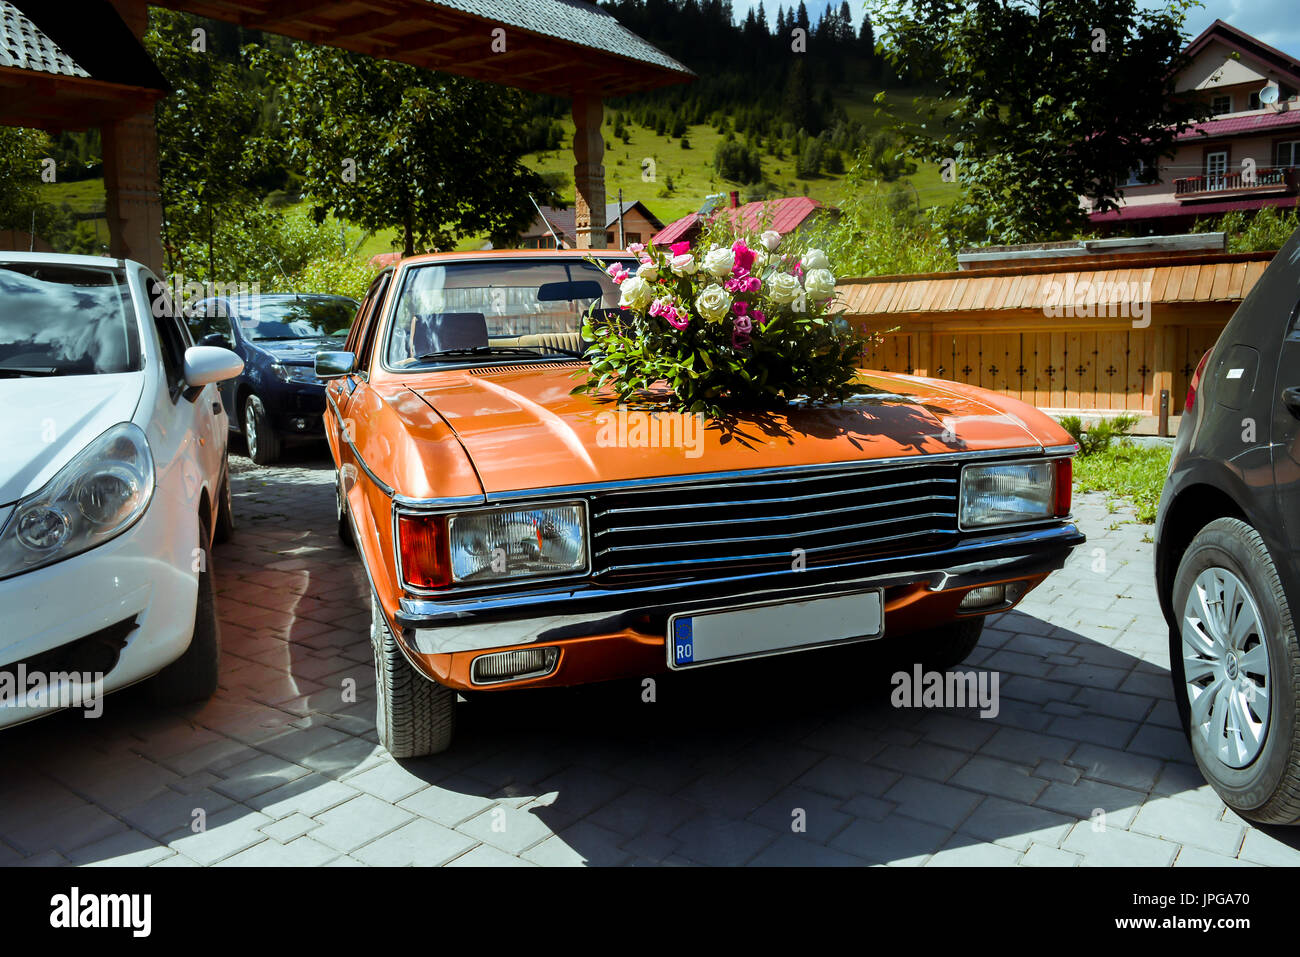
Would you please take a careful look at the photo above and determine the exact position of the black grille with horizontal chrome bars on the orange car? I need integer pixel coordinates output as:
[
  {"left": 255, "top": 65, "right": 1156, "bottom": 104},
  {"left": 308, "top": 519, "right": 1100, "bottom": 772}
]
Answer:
[{"left": 590, "top": 463, "right": 961, "bottom": 584}]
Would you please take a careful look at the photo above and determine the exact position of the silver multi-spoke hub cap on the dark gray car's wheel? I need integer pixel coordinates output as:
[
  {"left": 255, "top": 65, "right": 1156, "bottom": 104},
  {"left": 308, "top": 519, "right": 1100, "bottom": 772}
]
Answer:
[{"left": 1182, "top": 568, "right": 1270, "bottom": 767}]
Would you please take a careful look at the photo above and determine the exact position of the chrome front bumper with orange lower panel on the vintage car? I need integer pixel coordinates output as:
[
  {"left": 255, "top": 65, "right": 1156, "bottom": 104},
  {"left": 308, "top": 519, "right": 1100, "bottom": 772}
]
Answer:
[{"left": 393, "top": 524, "right": 1086, "bottom": 689}]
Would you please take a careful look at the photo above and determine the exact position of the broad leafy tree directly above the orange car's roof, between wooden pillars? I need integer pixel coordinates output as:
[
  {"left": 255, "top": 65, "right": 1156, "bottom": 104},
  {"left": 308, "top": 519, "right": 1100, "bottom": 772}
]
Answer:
[{"left": 265, "top": 44, "right": 543, "bottom": 255}]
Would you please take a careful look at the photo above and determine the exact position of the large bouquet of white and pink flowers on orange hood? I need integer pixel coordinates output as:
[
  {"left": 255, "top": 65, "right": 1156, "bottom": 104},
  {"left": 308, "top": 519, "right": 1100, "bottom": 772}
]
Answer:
[{"left": 573, "top": 230, "right": 862, "bottom": 416}]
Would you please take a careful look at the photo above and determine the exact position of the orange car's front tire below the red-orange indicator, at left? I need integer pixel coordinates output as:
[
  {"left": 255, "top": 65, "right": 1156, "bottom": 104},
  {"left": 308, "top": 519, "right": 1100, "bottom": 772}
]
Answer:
[{"left": 371, "top": 596, "right": 456, "bottom": 758}]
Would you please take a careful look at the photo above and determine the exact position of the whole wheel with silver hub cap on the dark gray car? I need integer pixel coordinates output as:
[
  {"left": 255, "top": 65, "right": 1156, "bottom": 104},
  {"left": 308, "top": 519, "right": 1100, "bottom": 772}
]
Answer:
[{"left": 1170, "top": 519, "right": 1300, "bottom": 824}]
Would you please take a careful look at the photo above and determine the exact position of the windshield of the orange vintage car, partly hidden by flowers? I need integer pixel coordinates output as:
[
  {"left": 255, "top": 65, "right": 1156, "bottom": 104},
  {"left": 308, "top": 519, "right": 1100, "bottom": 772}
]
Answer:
[{"left": 386, "top": 259, "right": 629, "bottom": 367}]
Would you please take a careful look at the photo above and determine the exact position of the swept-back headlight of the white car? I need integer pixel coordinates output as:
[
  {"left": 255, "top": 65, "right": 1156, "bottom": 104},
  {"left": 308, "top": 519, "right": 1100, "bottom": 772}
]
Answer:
[{"left": 0, "top": 423, "right": 153, "bottom": 579}]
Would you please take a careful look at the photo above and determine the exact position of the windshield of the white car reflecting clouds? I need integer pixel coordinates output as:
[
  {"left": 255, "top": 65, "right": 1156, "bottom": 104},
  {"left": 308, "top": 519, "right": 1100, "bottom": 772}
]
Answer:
[{"left": 0, "top": 263, "right": 140, "bottom": 378}]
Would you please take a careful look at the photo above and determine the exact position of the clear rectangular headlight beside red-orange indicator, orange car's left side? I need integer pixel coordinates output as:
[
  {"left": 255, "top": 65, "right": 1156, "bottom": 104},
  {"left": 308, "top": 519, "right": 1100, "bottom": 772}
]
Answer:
[{"left": 447, "top": 502, "right": 586, "bottom": 583}]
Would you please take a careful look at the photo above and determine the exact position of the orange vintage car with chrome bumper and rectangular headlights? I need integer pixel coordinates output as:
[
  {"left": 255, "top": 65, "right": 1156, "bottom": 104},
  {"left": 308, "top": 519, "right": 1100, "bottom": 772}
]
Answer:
[{"left": 316, "top": 251, "right": 1084, "bottom": 757}]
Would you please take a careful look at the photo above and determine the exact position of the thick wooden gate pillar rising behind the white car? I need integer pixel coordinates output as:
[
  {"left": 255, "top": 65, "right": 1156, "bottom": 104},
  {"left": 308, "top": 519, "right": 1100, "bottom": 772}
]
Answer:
[{"left": 101, "top": 0, "right": 163, "bottom": 277}]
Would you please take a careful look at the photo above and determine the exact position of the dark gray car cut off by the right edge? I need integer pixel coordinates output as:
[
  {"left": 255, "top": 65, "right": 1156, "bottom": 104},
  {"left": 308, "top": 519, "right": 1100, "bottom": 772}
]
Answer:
[{"left": 1156, "top": 230, "right": 1300, "bottom": 824}]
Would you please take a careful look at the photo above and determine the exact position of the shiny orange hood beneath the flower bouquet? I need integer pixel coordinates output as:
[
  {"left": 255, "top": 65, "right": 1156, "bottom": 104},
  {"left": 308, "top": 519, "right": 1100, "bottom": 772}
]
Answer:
[{"left": 407, "top": 367, "right": 1050, "bottom": 493}]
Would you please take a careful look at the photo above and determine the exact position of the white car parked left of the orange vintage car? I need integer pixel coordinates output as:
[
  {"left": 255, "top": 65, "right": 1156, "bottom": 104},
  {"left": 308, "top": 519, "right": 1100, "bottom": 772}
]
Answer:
[{"left": 0, "top": 251, "right": 243, "bottom": 727}]
